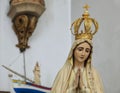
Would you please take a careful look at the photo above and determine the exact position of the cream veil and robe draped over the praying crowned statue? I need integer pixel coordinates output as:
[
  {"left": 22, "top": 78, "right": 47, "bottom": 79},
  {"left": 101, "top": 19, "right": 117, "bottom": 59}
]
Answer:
[{"left": 51, "top": 40, "right": 104, "bottom": 93}]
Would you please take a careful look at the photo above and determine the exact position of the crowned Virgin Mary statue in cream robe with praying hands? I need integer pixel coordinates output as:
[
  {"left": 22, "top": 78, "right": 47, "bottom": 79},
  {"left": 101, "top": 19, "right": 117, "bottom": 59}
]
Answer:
[{"left": 51, "top": 5, "right": 104, "bottom": 93}]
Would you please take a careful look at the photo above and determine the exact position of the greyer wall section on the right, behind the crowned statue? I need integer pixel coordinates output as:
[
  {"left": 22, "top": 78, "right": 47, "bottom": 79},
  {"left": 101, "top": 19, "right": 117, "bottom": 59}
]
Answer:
[{"left": 71, "top": 0, "right": 120, "bottom": 93}]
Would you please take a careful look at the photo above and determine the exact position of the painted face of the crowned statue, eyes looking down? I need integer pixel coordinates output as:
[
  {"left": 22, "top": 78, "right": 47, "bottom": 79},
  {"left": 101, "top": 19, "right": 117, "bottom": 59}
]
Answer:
[{"left": 74, "top": 42, "right": 91, "bottom": 62}]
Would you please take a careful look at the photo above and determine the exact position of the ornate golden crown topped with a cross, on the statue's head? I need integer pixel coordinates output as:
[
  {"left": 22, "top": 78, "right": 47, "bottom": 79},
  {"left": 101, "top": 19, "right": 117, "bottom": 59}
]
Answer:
[{"left": 71, "top": 4, "right": 98, "bottom": 40}]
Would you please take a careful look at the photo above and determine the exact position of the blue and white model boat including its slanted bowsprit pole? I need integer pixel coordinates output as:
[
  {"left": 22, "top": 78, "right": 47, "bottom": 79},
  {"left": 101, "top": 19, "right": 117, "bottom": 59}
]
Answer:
[{"left": 2, "top": 65, "right": 51, "bottom": 93}]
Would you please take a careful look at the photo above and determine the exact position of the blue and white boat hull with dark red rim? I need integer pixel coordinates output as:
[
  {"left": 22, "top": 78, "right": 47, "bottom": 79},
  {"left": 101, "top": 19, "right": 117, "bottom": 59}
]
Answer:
[{"left": 13, "top": 80, "right": 51, "bottom": 93}]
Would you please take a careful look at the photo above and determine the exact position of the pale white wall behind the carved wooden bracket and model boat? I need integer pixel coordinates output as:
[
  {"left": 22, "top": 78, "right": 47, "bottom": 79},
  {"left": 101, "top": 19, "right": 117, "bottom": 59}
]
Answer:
[{"left": 0, "top": 0, "right": 71, "bottom": 91}]
